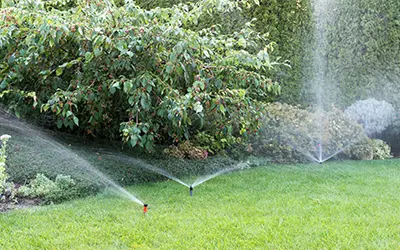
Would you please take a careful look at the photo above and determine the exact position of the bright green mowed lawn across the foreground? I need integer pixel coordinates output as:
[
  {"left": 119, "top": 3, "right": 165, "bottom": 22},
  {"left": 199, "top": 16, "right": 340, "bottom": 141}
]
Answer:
[{"left": 0, "top": 160, "right": 400, "bottom": 249}]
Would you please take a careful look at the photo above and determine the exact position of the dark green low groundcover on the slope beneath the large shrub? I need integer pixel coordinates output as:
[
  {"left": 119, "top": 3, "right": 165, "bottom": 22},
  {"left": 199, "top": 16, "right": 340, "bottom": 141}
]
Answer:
[{"left": 0, "top": 121, "right": 235, "bottom": 185}]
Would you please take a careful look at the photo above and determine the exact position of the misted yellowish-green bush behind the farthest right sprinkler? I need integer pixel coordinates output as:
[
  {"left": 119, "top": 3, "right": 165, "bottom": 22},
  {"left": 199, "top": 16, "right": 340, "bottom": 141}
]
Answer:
[{"left": 253, "top": 103, "right": 365, "bottom": 161}]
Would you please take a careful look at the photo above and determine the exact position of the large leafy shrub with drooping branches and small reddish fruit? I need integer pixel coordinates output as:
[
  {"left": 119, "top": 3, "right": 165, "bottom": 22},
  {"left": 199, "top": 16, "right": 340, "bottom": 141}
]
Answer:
[{"left": 0, "top": 0, "right": 281, "bottom": 150}]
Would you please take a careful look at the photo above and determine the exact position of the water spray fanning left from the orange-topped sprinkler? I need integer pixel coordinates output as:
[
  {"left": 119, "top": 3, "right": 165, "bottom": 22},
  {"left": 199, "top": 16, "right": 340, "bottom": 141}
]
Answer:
[{"left": 0, "top": 110, "right": 145, "bottom": 209}]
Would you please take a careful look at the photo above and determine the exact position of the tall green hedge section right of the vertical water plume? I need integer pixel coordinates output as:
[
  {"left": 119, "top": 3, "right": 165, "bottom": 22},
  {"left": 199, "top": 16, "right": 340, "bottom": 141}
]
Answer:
[{"left": 327, "top": 0, "right": 400, "bottom": 107}]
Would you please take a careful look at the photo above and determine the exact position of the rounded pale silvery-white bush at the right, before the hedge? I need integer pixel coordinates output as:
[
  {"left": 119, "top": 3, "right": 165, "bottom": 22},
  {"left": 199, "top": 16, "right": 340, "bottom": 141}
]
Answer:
[{"left": 345, "top": 98, "right": 395, "bottom": 137}]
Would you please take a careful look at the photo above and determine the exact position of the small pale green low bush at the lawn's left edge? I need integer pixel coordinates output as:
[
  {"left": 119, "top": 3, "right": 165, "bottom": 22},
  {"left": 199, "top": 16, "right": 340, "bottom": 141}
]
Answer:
[{"left": 18, "top": 174, "right": 77, "bottom": 202}]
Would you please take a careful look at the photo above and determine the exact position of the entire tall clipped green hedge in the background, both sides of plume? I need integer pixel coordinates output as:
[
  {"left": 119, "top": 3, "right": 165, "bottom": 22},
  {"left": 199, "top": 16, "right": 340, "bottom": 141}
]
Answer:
[{"left": 137, "top": 0, "right": 400, "bottom": 107}]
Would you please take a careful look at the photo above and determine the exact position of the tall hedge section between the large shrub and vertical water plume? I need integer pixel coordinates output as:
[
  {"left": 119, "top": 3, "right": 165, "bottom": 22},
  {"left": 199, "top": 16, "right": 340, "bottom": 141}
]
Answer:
[{"left": 136, "top": 0, "right": 313, "bottom": 104}]
